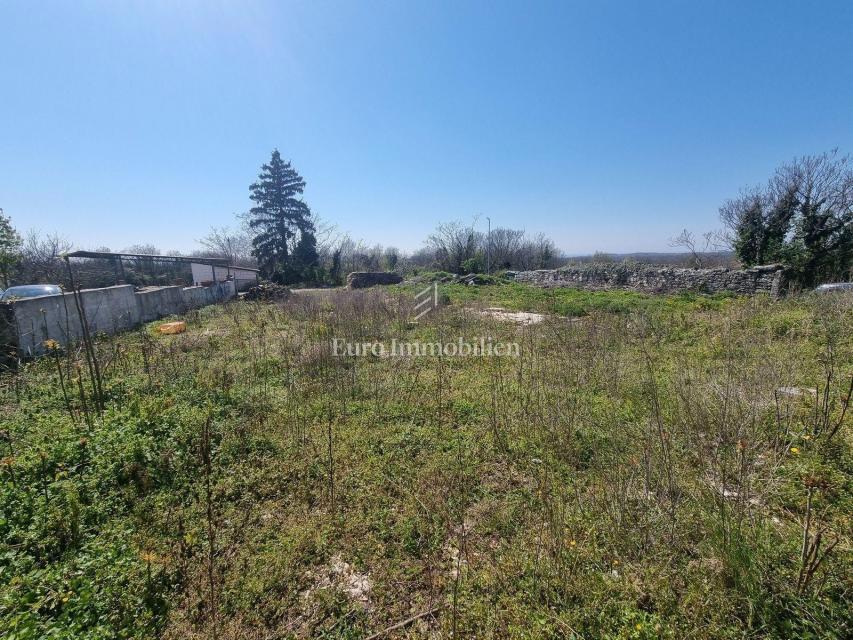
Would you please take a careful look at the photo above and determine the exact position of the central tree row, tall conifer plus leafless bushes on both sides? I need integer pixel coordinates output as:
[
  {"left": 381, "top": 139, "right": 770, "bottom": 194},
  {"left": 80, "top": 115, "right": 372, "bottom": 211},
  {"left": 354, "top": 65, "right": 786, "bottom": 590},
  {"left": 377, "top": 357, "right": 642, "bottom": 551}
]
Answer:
[{"left": 201, "top": 149, "right": 560, "bottom": 285}]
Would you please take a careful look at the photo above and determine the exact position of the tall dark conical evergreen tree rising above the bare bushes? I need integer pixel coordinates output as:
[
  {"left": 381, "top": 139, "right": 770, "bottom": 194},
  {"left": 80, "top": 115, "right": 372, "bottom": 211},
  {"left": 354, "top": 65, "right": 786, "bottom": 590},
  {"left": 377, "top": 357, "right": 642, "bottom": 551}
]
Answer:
[{"left": 249, "top": 149, "right": 314, "bottom": 280}]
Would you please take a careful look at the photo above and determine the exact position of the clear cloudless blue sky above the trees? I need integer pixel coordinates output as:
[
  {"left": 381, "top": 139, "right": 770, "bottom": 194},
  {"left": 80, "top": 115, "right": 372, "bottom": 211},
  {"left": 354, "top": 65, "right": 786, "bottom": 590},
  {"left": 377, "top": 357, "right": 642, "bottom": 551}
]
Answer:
[{"left": 0, "top": 0, "right": 853, "bottom": 253}]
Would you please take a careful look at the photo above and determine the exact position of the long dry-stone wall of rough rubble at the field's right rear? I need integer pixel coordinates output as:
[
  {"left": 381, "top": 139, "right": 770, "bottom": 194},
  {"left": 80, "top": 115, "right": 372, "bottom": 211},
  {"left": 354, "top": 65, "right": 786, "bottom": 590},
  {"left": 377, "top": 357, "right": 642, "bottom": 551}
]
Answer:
[{"left": 515, "top": 263, "right": 784, "bottom": 297}]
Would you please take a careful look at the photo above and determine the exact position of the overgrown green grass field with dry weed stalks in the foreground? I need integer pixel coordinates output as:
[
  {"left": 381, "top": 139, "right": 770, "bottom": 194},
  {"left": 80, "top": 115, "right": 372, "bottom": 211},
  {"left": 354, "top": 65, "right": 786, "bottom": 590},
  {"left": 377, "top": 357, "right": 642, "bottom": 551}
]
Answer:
[{"left": 0, "top": 284, "right": 853, "bottom": 640}]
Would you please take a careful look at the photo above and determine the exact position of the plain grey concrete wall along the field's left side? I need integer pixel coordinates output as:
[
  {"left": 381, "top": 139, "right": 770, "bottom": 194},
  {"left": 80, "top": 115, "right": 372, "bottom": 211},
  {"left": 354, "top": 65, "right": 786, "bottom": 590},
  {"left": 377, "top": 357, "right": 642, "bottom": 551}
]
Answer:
[{"left": 5, "top": 281, "right": 237, "bottom": 356}]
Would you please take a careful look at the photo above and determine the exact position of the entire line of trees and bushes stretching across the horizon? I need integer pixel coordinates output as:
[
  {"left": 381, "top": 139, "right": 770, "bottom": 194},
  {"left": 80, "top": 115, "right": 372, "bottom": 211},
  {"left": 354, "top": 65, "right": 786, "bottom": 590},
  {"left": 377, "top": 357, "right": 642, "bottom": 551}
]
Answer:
[{"left": 0, "top": 149, "right": 853, "bottom": 288}]
